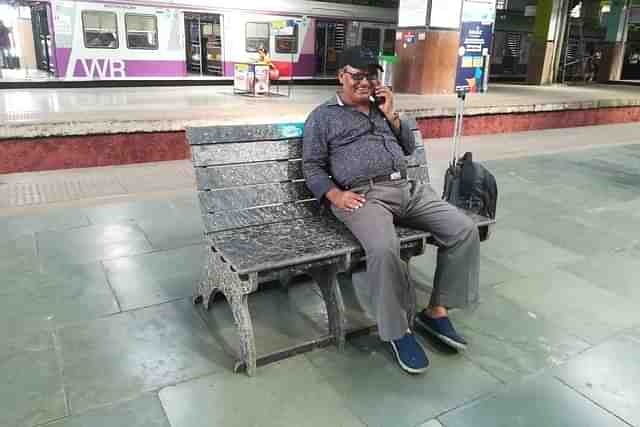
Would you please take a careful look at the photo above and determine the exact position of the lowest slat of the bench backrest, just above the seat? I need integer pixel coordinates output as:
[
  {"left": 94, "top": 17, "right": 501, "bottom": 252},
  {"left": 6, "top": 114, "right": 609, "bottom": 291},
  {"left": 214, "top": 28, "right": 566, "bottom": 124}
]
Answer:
[{"left": 203, "top": 201, "right": 320, "bottom": 233}]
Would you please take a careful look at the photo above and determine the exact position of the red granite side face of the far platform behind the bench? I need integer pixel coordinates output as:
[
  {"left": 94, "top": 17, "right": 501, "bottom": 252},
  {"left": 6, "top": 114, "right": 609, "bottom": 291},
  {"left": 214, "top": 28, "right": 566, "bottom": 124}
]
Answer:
[{"left": 0, "top": 107, "right": 640, "bottom": 173}]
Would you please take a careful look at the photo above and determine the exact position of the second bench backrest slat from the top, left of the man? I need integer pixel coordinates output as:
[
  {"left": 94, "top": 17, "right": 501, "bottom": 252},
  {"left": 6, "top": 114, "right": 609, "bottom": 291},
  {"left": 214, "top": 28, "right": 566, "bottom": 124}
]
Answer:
[{"left": 191, "top": 139, "right": 302, "bottom": 166}]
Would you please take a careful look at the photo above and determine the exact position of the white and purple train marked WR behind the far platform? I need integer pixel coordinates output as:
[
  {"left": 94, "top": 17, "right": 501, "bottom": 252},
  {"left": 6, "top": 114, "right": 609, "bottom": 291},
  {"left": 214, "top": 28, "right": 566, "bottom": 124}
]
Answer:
[{"left": 30, "top": 0, "right": 397, "bottom": 80}]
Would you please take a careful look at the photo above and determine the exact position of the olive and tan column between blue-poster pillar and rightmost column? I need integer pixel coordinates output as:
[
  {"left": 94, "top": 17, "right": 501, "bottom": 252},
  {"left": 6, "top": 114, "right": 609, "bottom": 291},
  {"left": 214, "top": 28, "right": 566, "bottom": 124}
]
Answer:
[{"left": 527, "top": 0, "right": 569, "bottom": 85}]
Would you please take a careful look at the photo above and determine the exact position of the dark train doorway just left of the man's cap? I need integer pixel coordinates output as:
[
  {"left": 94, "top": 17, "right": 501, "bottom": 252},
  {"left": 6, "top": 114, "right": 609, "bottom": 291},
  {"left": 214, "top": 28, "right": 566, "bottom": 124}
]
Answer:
[{"left": 315, "top": 21, "right": 346, "bottom": 76}]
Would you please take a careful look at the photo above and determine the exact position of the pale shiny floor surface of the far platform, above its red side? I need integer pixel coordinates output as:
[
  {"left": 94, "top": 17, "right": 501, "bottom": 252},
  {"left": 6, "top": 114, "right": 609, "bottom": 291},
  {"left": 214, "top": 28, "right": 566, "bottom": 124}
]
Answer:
[{"left": 0, "top": 84, "right": 640, "bottom": 139}]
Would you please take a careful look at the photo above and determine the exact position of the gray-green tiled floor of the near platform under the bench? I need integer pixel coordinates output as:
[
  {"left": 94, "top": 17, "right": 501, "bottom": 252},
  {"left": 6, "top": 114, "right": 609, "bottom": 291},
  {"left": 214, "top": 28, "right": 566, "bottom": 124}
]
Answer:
[{"left": 0, "top": 124, "right": 640, "bottom": 427}]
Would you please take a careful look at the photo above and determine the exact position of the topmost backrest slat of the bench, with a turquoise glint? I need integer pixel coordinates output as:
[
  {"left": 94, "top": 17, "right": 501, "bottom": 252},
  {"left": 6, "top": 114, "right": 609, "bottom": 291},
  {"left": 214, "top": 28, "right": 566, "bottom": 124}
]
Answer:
[{"left": 187, "top": 123, "right": 304, "bottom": 145}]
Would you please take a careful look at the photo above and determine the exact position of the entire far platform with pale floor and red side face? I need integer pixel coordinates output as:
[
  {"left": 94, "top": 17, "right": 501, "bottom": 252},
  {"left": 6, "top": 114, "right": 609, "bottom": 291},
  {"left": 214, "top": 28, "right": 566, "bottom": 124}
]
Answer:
[{"left": 0, "top": 84, "right": 640, "bottom": 173}]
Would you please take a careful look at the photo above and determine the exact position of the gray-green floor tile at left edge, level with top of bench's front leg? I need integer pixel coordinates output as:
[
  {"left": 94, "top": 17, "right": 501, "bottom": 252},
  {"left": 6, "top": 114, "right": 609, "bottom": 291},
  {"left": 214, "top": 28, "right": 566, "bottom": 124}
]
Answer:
[{"left": 0, "top": 263, "right": 119, "bottom": 328}]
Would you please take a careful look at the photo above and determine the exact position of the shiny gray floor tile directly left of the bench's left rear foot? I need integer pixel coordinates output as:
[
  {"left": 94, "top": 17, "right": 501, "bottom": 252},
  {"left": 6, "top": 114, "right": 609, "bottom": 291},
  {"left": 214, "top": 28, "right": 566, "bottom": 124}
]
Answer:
[{"left": 103, "top": 246, "right": 205, "bottom": 310}]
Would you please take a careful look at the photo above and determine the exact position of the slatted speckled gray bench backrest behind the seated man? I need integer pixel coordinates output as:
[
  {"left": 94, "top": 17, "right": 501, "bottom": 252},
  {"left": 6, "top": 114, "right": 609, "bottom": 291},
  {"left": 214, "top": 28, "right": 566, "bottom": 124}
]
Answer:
[{"left": 187, "top": 120, "right": 429, "bottom": 234}]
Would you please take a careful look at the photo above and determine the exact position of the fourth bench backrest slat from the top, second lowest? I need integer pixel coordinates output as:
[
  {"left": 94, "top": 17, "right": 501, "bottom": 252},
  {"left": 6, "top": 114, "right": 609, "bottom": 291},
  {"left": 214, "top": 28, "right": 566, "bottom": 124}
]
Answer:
[{"left": 198, "top": 181, "right": 313, "bottom": 212}]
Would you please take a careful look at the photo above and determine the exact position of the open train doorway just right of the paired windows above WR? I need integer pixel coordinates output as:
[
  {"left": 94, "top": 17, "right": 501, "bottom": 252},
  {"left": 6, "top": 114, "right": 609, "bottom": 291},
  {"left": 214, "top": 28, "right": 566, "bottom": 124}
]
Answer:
[{"left": 184, "top": 13, "right": 223, "bottom": 76}]
